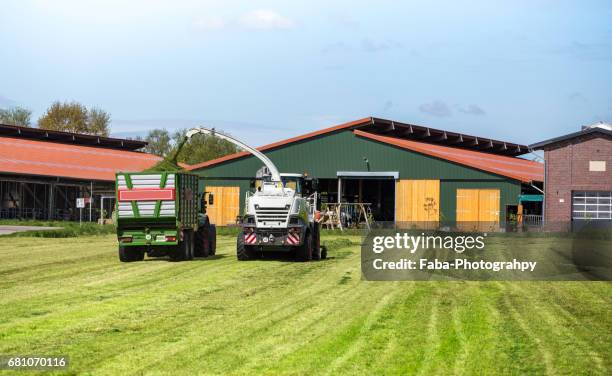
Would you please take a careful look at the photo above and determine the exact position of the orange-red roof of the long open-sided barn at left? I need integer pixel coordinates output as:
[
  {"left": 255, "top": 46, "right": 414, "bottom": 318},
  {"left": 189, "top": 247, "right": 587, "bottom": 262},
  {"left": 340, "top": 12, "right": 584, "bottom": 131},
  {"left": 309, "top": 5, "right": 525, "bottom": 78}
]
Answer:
[{"left": 0, "top": 137, "right": 161, "bottom": 181}]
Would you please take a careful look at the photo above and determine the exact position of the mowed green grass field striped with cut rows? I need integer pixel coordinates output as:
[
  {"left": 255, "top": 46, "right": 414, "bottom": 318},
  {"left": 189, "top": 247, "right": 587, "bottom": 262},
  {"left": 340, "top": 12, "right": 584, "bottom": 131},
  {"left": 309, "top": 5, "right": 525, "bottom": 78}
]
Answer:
[{"left": 0, "top": 235, "right": 612, "bottom": 375}]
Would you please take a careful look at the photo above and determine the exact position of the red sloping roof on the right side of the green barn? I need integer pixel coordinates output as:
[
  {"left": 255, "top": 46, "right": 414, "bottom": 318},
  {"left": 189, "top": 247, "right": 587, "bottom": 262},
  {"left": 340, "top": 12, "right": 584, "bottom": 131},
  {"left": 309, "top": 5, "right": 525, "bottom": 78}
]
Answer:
[{"left": 353, "top": 129, "right": 544, "bottom": 182}]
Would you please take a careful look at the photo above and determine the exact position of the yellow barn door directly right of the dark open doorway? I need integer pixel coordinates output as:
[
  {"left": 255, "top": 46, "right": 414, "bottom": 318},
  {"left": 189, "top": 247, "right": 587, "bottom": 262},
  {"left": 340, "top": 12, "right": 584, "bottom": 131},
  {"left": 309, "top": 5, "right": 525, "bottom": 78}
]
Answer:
[{"left": 395, "top": 180, "right": 440, "bottom": 227}]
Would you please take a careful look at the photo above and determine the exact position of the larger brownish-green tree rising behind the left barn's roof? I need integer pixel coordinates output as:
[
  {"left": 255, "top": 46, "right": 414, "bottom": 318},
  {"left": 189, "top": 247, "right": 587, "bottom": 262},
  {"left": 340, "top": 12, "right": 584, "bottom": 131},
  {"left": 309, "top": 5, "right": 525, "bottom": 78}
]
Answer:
[{"left": 38, "top": 102, "right": 110, "bottom": 136}]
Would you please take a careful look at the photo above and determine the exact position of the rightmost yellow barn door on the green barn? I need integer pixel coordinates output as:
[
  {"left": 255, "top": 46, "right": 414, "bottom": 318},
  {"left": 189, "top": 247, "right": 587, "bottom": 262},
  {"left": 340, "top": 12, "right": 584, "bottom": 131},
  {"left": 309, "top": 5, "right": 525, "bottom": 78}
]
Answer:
[{"left": 457, "top": 189, "right": 500, "bottom": 231}]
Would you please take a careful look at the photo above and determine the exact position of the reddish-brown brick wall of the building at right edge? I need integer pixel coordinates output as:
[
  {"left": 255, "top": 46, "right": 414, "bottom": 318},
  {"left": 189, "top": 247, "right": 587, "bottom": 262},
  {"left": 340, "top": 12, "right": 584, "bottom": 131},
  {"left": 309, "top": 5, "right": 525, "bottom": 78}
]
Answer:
[{"left": 544, "top": 134, "right": 612, "bottom": 223}]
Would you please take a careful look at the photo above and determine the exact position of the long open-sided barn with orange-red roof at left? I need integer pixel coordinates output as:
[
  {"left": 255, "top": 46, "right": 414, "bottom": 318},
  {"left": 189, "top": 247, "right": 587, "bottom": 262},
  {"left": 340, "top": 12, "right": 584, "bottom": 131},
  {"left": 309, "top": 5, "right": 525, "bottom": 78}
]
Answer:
[{"left": 0, "top": 125, "right": 160, "bottom": 221}]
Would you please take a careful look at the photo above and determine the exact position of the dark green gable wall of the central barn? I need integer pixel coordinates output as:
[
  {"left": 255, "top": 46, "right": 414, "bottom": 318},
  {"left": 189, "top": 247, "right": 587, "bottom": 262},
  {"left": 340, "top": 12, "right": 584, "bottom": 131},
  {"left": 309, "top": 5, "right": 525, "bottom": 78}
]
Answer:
[{"left": 193, "top": 130, "right": 521, "bottom": 221}]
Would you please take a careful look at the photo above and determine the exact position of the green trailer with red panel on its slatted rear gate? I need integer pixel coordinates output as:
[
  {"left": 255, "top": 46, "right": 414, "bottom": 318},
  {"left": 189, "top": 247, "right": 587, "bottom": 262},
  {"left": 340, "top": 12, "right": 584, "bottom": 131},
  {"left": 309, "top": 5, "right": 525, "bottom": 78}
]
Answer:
[{"left": 115, "top": 172, "right": 216, "bottom": 262}]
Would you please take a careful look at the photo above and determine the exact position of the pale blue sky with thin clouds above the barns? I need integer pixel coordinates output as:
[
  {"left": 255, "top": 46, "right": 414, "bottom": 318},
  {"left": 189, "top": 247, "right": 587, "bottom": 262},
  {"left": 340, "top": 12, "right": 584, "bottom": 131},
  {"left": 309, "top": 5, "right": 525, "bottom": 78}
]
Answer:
[{"left": 0, "top": 0, "right": 612, "bottom": 145}]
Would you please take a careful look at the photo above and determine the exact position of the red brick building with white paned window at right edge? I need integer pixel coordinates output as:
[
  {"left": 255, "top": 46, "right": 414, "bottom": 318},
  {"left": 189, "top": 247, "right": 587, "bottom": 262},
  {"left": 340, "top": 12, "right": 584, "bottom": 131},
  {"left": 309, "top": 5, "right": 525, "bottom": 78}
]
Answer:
[{"left": 531, "top": 123, "right": 612, "bottom": 227}]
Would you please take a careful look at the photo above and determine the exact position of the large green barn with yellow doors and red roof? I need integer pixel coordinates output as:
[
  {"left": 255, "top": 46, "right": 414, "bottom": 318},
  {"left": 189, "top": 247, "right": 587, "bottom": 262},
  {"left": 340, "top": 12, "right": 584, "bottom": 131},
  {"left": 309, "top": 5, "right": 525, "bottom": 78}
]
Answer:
[{"left": 189, "top": 118, "right": 544, "bottom": 225}]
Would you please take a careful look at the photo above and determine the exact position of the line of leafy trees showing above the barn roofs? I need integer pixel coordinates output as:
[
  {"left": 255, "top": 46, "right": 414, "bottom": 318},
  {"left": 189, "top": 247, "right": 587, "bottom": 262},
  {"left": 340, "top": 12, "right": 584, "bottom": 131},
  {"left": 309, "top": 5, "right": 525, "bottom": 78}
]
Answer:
[{"left": 0, "top": 101, "right": 238, "bottom": 164}]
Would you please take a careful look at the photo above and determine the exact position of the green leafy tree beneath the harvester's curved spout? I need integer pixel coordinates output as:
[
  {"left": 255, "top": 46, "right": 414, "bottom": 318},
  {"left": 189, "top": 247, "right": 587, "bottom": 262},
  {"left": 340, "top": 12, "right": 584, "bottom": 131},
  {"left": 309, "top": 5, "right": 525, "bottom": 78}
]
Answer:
[{"left": 173, "top": 130, "right": 238, "bottom": 165}]
